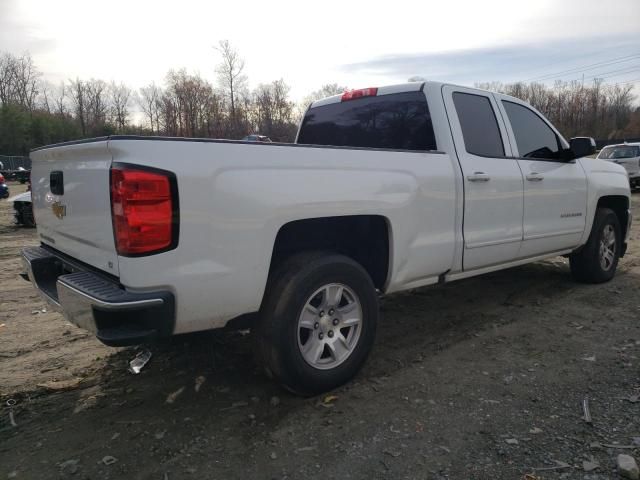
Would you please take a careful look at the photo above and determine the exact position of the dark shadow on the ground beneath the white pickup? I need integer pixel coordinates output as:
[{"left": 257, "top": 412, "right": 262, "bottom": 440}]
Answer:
[{"left": 40, "top": 259, "right": 589, "bottom": 415}]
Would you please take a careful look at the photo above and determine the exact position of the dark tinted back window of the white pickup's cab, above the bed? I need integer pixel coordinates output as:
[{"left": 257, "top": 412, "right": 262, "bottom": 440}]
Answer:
[{"left": 297, "top": 92, "right": 437, "bottom": 150}]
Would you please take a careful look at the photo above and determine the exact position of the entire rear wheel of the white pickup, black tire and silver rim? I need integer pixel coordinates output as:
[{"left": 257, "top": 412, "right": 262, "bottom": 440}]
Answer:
[{"left": 257, "top": 252, "right": 378, "bottom": 395}]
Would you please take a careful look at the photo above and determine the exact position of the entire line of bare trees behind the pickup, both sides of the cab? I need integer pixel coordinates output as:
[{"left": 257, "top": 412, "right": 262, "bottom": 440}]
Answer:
[{"left": 0, "top": 41, "right": 640, "bottom": 155}]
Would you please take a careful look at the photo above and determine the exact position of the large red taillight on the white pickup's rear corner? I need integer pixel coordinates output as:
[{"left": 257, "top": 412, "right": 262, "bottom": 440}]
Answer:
[{"left": 111, "top": 167, "right": 177, "bottom": 256}]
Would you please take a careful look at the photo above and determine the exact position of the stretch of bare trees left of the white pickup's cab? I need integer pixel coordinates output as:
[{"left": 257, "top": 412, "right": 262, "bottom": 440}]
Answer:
[{"left": 0, "top": 41, "right": 336, "bottom": 155}]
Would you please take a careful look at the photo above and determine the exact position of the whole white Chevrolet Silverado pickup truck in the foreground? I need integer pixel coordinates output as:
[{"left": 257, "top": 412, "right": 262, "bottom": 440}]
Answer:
[{"left": 23, "top": 82, "right": 631, "bottom": 395}]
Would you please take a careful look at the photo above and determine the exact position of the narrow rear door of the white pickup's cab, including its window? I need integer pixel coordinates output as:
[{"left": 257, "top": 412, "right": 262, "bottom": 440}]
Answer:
[{"left": 442, "top": 86, "right": 523, "bottom": 270}]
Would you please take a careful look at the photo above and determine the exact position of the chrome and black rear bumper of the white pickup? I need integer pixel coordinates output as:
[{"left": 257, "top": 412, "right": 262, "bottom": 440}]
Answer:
[{"left": 22, "top": 247, "right": 175, "bottom": 346}]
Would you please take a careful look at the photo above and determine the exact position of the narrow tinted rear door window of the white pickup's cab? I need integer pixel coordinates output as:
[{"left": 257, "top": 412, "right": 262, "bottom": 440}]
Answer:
[{"left": 453, "top": 92, "right": 504, "bottom": 157}]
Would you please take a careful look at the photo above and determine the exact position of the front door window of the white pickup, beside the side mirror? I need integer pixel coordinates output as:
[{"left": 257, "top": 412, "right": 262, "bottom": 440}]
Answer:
[{"left": 502, "top": 100, "right": 562, "bottom": 160}]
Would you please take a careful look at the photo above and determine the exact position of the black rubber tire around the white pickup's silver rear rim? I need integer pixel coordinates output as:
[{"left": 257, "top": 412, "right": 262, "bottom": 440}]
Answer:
[{"left": 256, "top": 252, "right": 378, "bottom": 396}]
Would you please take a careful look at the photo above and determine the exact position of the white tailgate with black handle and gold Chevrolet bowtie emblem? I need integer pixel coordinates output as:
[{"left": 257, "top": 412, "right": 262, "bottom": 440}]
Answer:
[{"left": 31, "top": 139, "right": 118, "bottom": 275}]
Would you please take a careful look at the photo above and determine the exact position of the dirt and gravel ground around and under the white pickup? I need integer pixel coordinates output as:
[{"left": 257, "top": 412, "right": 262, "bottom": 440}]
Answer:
[{"left": 0, "top": 181, "right": 640, "bottom": 480}]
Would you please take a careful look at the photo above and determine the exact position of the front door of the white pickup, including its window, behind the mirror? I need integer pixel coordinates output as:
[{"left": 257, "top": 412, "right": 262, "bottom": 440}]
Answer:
[{"left": 499, "top": 97, "right": 587, "bottom": 257}]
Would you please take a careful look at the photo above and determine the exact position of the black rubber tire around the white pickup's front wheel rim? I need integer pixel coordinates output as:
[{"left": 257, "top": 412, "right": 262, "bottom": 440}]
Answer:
[{"left": 569, "top": 208, "right": 622, "bottom": 283}]
